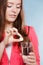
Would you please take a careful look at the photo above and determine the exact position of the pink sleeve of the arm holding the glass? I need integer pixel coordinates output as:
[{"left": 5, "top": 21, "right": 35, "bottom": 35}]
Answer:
[{"left": 28, "top": 26, "right": 40, "bottom": 65}]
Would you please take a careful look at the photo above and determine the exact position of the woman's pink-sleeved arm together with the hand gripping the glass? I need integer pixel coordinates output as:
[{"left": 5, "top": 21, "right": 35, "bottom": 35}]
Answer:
[{"left": 23, "top": 26, "right": 40, "bottom": 65}]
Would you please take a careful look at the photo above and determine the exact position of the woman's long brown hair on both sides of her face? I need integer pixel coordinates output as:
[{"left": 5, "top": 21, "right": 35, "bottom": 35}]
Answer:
[{"left": 0, "top": 0, "right": 27, "bottom": 42}]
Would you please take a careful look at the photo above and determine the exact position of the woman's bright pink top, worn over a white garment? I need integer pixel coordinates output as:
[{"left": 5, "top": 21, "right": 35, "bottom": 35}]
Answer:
[{"left": 0, "top": 26, "right": 40, "bottom": 65}]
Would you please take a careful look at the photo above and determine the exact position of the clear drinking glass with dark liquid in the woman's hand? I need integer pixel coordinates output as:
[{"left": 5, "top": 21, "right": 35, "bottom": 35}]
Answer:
[{"left": 21, "top": 41, "right": 33, "bottom": 55}]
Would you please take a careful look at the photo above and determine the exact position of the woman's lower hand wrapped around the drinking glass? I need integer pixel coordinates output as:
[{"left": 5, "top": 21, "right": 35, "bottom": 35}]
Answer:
[{"left": 22, "top": 52, "right": 37, "bottom": 65}]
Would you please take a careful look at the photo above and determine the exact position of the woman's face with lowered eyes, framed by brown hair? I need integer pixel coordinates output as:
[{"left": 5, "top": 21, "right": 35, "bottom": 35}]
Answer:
[{"left": 5, "top": 0, "right": 21, "bottom": 22}]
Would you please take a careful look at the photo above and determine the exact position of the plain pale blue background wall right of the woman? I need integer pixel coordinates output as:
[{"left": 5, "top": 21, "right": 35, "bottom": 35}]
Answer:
[{"left": 23, "top": 0, "right": 43, "bottom": 65}]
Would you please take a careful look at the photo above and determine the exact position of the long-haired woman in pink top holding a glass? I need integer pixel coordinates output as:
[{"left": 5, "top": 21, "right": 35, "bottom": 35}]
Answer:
[{"left": 0, "top": 0, "right": 40, "bottom": 65}]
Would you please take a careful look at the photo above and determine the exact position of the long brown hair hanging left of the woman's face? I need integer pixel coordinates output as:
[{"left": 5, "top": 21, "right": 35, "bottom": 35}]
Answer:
[{"left": 0, "top": 0, "right": 7, "bottom": 39}]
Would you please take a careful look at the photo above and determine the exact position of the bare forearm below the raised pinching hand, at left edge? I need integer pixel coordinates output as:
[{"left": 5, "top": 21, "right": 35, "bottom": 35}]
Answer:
[{"left": 0, "top": 28, "right": 11, "bottom": 61}]
